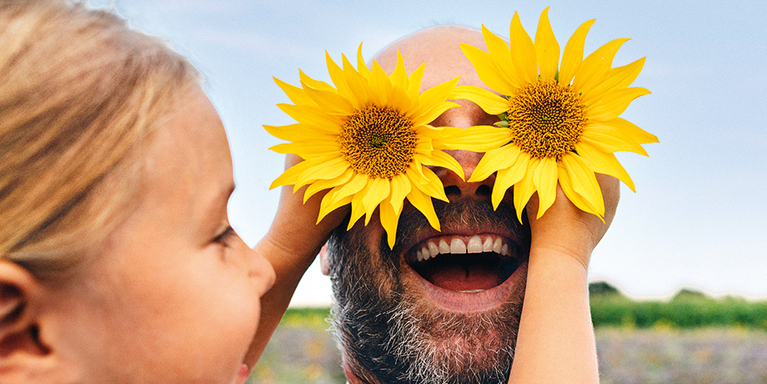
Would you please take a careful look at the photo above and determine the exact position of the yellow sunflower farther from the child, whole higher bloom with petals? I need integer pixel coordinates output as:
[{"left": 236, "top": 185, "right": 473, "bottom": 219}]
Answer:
[{"left": 451, "top": 8, "right": 658, "bottom": 220}]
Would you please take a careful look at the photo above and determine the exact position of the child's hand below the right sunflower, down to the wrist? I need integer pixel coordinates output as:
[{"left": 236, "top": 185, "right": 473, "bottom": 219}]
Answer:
[{"left": 527, "top": 174, "right": 620, "bottom": 269}]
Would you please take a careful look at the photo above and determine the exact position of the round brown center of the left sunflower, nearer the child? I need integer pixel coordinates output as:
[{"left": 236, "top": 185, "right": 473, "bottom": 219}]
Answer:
[{"left": 338, "top": 104, "right": 416, "bottom": 179}]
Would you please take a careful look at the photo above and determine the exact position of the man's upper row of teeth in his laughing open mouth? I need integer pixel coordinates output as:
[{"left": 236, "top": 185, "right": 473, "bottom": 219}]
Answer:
[{"left": 415, "top": 235, "right": 510, "bottom": 261}]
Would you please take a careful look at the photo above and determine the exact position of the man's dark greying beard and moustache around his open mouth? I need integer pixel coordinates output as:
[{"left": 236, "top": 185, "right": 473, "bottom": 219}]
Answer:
[{"left": 329, "top": 199, "right": 529, "bottom": 384}]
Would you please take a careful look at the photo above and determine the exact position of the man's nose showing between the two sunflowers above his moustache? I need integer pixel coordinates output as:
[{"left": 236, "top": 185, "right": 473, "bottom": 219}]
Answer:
[{"left": 434, "top": 150, "right": 495, "bottom": 200}]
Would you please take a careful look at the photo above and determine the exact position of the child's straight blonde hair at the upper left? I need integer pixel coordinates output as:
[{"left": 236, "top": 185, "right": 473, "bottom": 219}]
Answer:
[{"left": 0, "top": 0, "right": 200, "bottom": 280}]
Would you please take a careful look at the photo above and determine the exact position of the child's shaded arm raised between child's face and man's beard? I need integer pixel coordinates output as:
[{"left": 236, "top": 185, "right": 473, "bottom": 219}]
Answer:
[{"left": 253, "top": 155, "right": 349, "bottom": 360}]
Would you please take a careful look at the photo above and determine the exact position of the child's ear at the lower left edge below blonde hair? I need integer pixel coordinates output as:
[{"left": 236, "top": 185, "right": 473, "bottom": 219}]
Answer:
[{"left": 0, "top": 260, "right": 51, "bottom": 383}]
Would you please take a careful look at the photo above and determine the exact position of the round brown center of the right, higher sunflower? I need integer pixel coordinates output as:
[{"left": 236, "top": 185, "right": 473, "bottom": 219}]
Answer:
[{"left": 506, "top": 81, "right": 586, "bottom": 160}]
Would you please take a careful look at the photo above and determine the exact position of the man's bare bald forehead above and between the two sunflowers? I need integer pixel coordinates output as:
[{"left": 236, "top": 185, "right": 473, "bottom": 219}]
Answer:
[{"left": 374, "top": 25, "right": 487, "bottom": 90}]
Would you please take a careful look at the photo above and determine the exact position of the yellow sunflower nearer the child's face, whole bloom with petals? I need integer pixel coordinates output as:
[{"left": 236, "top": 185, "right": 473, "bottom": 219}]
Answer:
[{"left": 264, "top": 45, "right": 463, "bottom": 247}]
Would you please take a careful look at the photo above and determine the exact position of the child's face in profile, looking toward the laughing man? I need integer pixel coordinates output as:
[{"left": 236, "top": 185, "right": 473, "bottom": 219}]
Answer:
[{"left": 60, "top": 90, "right": 274, "bottom": 383}]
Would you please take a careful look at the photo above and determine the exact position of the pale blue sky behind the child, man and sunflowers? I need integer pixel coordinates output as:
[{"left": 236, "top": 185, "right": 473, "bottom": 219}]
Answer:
[{"left": 97, "top": 0, "right": 767, "bottom": 306}]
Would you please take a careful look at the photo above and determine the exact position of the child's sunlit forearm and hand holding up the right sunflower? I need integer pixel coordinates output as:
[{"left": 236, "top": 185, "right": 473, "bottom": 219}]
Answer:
[{"left": 509, "top": 175, "right": 620, "bottom": 384}]
